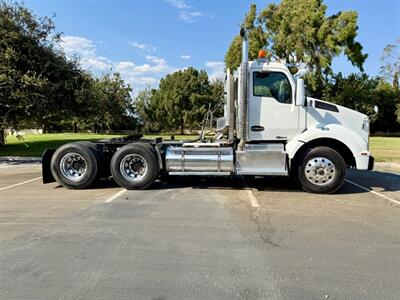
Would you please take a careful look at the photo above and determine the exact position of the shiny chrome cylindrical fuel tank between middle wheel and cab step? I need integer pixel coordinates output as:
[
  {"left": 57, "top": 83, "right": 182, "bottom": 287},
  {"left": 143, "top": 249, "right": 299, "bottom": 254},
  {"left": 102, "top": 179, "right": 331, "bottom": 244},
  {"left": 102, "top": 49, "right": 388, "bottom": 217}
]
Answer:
[{"left": 165, "top": 146, "right": 234, "bottom": 175}]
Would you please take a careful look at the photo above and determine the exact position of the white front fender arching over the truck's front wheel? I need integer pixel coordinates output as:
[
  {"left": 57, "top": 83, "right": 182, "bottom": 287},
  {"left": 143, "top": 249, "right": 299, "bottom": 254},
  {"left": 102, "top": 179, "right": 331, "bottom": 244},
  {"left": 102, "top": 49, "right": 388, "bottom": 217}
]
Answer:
[{"left": 286, "top": 124, "right": 370, "bottom": 170}]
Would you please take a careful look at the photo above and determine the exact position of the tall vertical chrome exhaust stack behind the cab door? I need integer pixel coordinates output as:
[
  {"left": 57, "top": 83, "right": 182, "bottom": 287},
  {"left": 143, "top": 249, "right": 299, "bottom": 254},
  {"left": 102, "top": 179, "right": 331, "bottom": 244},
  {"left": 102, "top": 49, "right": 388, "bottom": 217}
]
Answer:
[{"left": 238, "top": 28, "right": 249, "bottom": 151}]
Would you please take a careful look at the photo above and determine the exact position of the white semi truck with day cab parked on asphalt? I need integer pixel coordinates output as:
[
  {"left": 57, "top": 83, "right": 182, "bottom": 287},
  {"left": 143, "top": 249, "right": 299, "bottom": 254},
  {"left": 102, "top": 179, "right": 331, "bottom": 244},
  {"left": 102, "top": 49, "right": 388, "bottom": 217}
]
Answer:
[{"left": 42, "top": 30, "right": 374, "bottom": 193}]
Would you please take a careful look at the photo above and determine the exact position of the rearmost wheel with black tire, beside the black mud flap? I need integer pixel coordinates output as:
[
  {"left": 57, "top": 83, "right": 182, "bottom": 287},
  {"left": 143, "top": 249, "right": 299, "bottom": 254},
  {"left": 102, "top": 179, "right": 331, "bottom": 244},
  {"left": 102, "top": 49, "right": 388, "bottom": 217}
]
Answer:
[{"left": 50, "top": 142, "right": 103, "bottom": 189}]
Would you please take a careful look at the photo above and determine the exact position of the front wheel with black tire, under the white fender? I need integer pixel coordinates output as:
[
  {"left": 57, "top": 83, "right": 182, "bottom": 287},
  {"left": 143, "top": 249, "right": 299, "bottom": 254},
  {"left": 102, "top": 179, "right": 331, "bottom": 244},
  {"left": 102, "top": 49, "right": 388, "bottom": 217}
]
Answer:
[{"left": 294, "top": 147, "right": 346, "bottom": 194}]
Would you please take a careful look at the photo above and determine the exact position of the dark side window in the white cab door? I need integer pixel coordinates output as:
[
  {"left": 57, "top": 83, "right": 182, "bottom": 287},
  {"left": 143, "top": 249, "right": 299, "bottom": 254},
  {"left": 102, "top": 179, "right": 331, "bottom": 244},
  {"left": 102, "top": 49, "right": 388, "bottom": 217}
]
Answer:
[{"left": 253, "top": 72, "right": 292, "bottom": 104}]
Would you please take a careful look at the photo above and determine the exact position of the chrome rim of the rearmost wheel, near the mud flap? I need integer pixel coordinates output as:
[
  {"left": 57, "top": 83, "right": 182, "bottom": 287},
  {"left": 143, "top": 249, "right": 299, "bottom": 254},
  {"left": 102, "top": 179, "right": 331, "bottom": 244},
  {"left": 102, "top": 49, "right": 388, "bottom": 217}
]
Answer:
[{"left": 60, "top": 152, "right": 87, "bottom": 181}]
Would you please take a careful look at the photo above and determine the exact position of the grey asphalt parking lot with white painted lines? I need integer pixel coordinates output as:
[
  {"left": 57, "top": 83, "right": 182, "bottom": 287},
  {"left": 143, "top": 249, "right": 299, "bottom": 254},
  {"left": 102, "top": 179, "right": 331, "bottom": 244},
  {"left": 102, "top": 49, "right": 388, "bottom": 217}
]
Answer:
[{"left": 0, "top": 164, "right": 400, "bottom": 299}]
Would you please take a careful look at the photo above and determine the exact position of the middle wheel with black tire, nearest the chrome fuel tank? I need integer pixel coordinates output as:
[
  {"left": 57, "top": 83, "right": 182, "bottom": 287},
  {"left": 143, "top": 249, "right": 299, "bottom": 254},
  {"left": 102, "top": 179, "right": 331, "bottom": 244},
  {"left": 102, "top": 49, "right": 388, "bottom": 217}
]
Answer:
[{"left": 110, "top": 144, "right": 160, "bottom": 190}]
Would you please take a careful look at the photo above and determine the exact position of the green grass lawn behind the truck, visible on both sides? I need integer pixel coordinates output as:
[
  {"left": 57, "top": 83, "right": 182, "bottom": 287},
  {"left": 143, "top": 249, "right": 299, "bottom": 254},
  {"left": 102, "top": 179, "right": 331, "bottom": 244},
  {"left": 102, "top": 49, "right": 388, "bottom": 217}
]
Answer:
[{"left": 0, "top": 133, "right": 400, "bottom": 163}]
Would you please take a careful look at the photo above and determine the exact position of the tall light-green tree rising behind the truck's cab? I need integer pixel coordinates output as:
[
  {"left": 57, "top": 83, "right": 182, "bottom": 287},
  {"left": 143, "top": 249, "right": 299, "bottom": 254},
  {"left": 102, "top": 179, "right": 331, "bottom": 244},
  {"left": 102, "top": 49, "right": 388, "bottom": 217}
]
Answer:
[{"left": 225, "top": 0, "right": 367, "bottom": 96}]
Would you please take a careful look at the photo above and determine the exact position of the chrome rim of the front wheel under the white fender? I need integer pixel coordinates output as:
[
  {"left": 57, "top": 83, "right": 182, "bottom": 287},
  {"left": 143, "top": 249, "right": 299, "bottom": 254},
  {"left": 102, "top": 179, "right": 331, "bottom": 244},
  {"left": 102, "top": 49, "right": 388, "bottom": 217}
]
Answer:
[{"left": 304, "top": 157, "right": 336, "bottom": 185}]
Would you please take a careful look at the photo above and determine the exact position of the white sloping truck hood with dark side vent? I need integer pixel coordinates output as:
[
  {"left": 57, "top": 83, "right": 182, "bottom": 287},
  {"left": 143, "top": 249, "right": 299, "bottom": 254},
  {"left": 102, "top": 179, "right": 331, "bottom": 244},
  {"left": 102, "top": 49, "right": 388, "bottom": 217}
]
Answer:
[{"left": 307, "top": 97, "right": 369, "bottom": 141}]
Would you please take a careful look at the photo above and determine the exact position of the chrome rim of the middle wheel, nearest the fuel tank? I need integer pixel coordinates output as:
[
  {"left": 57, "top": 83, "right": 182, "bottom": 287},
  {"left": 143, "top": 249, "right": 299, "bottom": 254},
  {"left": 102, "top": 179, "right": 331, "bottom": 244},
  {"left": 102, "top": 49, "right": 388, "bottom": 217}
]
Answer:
[{"left": 120, "top": 154, "right": 147, "bottom": 181}]
